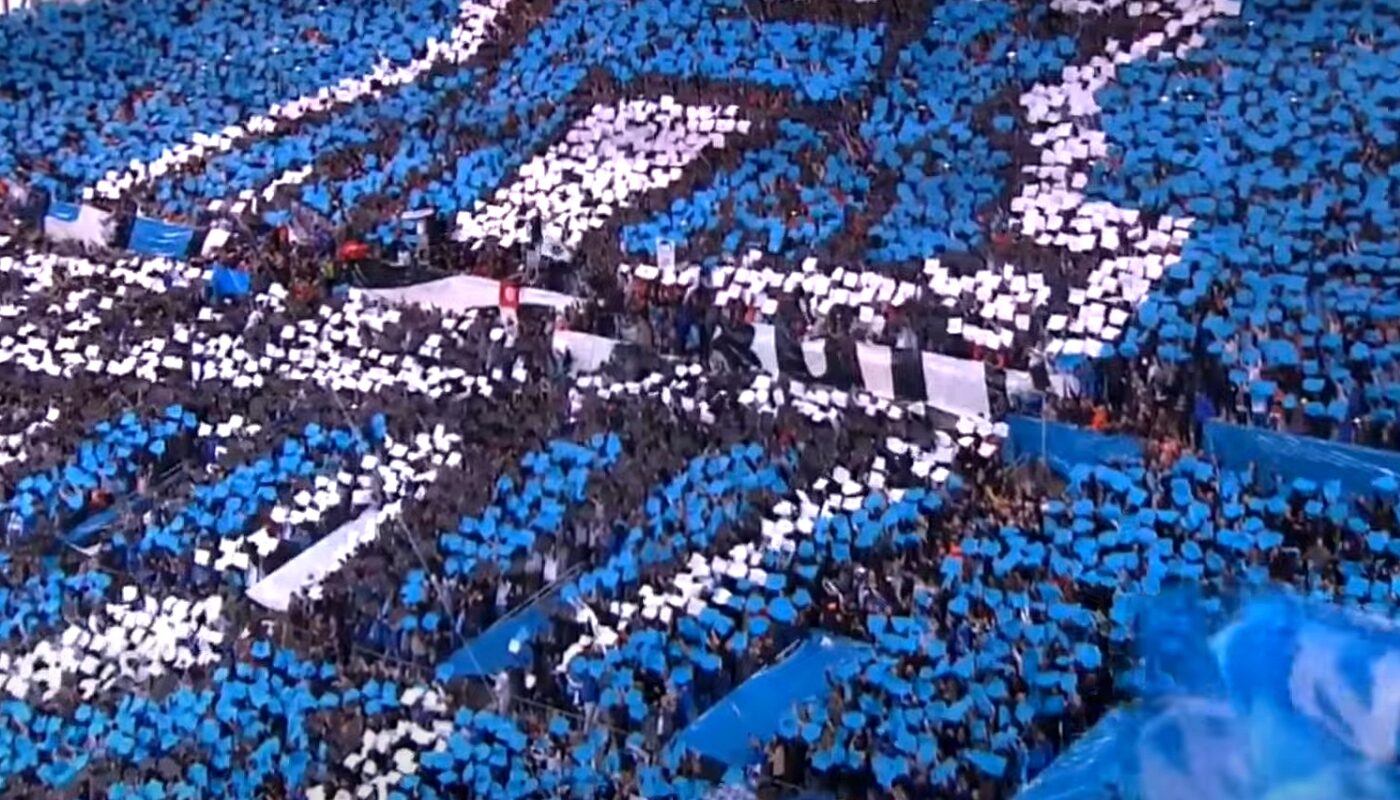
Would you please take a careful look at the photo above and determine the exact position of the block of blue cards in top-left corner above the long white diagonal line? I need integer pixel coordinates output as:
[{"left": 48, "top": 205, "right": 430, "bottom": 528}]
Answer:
[{"left": 0, "top": 0, "right": 476, "bottom": 198}]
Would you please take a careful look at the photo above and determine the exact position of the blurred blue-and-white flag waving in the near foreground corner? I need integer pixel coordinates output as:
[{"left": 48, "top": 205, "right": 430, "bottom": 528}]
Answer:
[{"left": 1021, "top": 595, "right": 1400, "bottom": 800}]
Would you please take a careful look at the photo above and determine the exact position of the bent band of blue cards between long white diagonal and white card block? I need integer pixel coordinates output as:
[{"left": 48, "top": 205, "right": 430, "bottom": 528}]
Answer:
[{"left": 112, "top": 3, "right": 878, "bottom": 238}]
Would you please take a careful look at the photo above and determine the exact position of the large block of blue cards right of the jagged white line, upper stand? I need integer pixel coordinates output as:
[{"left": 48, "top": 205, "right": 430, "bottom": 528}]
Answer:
[{"left": 1041, "top": 3, "right": 1400, "bottom": 446}]
